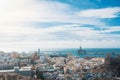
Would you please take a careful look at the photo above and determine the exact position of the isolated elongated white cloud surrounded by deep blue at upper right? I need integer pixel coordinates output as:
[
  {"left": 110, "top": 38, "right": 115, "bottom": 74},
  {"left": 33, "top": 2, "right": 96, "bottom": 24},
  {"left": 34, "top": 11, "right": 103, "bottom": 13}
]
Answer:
[{"left": 77, "top": 7, "right": 120, "bottom": 18}]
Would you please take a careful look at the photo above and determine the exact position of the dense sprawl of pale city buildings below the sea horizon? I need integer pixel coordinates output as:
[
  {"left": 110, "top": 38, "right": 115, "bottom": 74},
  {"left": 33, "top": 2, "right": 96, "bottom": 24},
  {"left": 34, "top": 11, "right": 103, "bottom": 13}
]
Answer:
[{"left": 0, "top": 47, "right": 120, "bottom": 80}]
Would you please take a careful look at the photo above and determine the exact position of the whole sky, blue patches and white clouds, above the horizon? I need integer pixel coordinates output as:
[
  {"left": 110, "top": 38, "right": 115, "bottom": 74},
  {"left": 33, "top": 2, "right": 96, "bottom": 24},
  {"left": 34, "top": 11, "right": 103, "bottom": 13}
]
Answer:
[{"left": 0, "top": 0, "right": 120, "bottom": 51}]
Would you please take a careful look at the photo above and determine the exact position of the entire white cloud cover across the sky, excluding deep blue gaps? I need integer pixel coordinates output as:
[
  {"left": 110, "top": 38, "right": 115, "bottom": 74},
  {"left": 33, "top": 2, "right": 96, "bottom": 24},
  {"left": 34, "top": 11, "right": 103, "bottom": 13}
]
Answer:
[{"left": 0, "top": 0, "right": 120, "bottom": 51}]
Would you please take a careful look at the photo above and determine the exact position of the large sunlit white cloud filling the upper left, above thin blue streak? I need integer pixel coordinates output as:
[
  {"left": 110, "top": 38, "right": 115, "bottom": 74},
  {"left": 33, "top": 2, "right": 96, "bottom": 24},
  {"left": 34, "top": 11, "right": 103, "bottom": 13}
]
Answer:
[{"left": 0, "top": 0, "right": 102, "bottom": 25}]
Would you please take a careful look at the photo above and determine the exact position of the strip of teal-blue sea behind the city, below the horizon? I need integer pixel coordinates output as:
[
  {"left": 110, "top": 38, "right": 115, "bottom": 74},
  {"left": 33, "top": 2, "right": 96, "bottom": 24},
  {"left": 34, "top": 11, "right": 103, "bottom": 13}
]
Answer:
[{"left": 41, "top": 48, "right": 120, "bottom": 58}]
